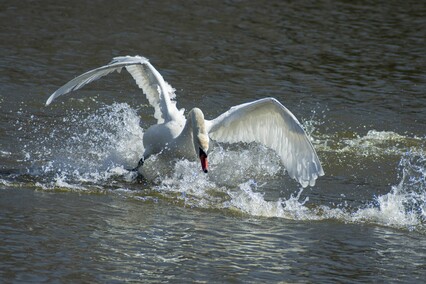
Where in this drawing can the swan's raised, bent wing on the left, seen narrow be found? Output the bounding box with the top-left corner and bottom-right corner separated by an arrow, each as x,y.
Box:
46,56 -> 183,123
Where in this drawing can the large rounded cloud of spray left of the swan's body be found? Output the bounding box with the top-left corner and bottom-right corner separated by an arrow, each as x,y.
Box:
23,103 -> 143,187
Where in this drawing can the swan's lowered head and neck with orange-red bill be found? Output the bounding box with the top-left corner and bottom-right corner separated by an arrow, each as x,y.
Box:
190,108 -> 209,173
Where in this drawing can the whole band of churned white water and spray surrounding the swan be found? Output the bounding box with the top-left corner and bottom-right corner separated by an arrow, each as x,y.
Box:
5,103 -> 426,233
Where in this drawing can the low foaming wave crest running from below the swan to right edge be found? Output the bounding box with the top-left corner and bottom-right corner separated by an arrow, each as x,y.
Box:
147,150 -> 426,233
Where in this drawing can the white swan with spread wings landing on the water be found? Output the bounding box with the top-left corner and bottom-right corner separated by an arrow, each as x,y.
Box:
46,56 -> 324,187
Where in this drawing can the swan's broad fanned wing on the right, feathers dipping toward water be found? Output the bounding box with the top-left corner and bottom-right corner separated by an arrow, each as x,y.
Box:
207,98 -> 324,187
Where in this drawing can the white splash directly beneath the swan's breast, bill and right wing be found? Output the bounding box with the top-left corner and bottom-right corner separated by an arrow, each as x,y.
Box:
143,144 -> 282,209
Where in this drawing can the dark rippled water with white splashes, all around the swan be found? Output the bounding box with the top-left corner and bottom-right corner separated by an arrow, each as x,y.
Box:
0,1 -> 426,283
